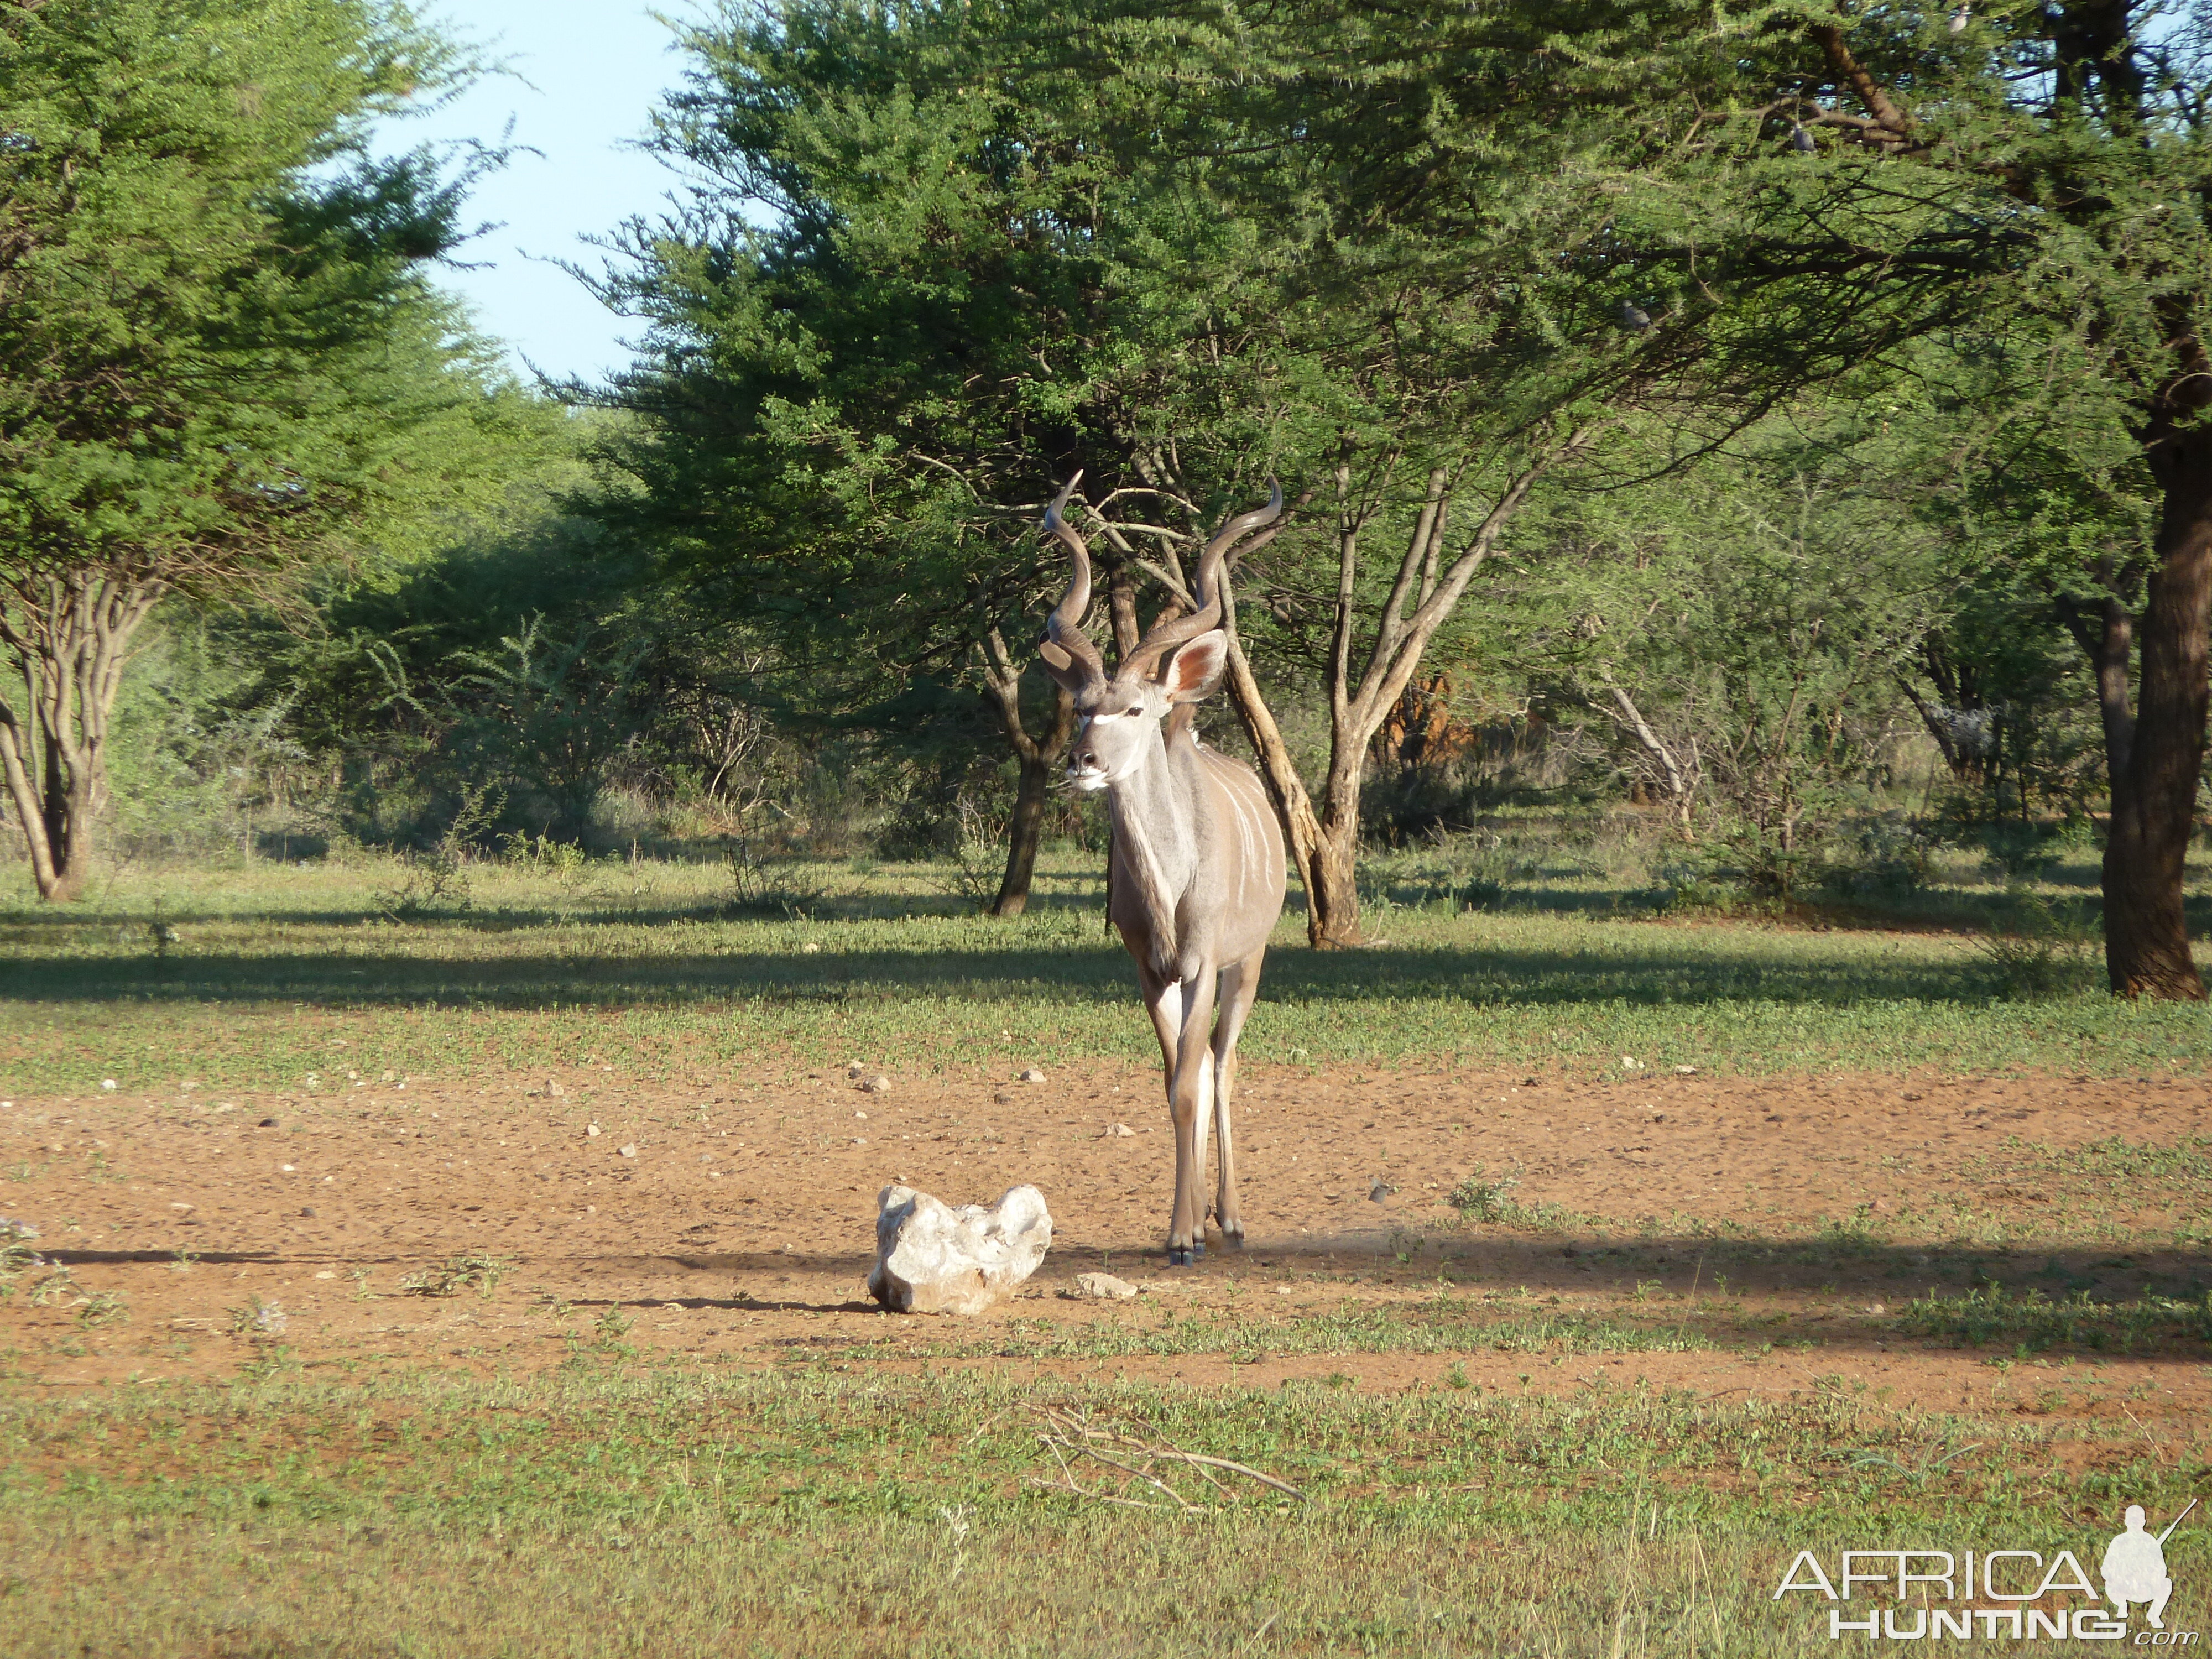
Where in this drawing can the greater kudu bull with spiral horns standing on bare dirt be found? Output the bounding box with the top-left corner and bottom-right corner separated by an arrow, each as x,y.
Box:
1037,473 -> 1287,1267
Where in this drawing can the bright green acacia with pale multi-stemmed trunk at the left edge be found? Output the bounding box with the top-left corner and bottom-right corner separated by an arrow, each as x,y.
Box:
0,0 -> 507,900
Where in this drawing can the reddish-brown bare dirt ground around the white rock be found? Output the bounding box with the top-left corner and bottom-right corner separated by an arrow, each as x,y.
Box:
0,1055 -> 2212,1431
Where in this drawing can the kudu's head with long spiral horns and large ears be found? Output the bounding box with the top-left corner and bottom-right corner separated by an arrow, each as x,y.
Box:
1037,473 -> 1283,794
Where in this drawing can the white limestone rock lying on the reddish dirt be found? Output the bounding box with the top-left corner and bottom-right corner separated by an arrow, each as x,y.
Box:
867,1183 -> 1053,1314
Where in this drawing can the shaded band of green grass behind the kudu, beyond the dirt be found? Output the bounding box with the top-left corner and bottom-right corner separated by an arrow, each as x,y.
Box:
0,854 -> 2212,1091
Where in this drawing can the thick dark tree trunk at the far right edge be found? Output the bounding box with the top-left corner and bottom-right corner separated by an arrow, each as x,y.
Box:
2099,420 -> 2212,1002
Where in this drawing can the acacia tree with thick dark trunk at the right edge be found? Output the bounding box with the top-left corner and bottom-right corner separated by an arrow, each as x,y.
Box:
1778,0 -> 2212,1000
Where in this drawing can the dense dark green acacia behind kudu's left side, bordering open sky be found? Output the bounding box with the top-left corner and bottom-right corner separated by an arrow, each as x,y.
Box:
597,0 -> 1345,916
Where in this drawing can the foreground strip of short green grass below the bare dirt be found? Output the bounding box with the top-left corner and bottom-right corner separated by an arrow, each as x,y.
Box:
0,1360 -> 2212,1659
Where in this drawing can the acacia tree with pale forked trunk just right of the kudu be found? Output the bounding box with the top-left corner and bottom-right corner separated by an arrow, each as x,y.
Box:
1024,23 -> 1681,949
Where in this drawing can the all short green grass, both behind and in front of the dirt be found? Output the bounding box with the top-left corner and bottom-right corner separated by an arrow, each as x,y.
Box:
0,856 -> 2212,1659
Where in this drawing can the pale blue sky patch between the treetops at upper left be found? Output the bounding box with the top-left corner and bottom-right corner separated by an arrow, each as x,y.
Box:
385,0 -> 699,376
